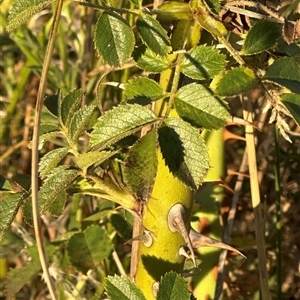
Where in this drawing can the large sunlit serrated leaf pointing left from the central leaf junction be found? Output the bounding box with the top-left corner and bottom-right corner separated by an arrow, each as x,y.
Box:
90,104 -> 157,149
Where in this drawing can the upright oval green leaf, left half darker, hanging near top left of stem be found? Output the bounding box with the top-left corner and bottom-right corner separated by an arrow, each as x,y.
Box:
94,12 -> 135,66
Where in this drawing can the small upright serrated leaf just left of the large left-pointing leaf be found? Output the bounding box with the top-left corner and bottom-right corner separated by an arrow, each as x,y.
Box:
69,105 -> 96,143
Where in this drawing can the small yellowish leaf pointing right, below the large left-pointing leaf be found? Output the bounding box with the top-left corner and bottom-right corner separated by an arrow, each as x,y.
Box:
77,151 -> 116,170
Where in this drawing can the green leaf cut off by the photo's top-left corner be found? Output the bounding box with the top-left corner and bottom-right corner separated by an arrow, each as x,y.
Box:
6,0 -> 55,32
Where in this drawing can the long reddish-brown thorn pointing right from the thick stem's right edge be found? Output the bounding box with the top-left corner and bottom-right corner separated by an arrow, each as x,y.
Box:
189,228 -> 246,258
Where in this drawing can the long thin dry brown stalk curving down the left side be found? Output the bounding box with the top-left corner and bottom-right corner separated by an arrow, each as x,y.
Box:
31,0 -> 63,300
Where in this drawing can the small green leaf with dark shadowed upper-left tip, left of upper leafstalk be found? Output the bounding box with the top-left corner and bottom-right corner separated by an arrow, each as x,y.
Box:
133,45 -> 170,73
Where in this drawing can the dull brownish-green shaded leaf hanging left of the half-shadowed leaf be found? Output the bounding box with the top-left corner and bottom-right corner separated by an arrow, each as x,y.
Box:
124,130 -> 157,201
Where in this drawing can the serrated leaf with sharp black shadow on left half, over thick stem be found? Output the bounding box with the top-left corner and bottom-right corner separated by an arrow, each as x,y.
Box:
159,118 -> 209,188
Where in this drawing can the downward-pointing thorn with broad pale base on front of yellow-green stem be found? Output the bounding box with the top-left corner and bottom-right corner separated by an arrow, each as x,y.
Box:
168,203 -> 196,267
